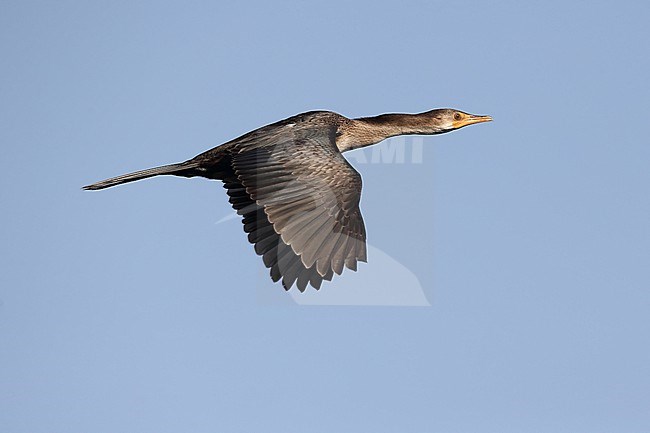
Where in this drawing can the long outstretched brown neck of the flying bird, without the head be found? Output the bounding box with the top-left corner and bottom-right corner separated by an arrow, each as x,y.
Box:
336,113 -> 442,152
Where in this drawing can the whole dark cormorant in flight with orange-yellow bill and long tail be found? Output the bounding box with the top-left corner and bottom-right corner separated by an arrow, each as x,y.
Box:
83,108 -> 492,292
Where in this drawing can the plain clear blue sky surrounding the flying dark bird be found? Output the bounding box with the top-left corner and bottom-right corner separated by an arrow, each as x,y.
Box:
0,1 -> 650,433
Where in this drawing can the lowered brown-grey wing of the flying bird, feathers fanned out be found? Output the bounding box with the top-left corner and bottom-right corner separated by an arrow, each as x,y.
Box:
224,121 -> 366,291
